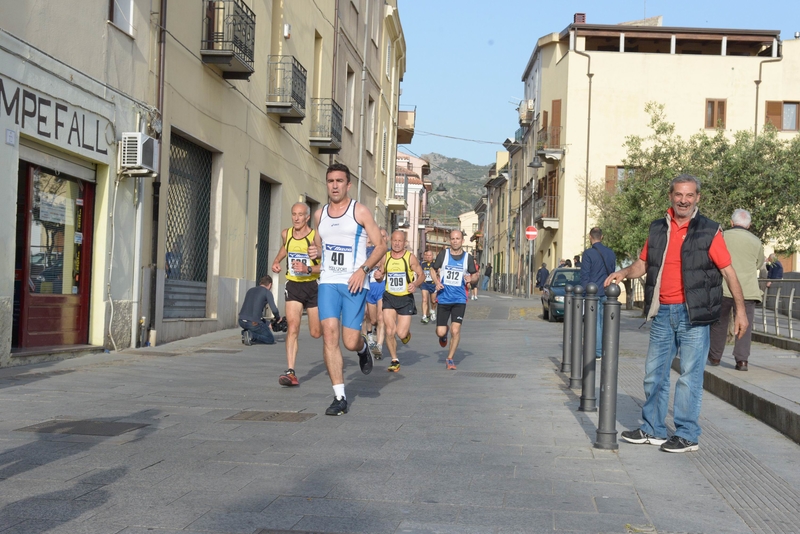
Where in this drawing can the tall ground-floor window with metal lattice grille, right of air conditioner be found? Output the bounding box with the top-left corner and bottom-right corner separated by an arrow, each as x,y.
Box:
164,133 -> 211,318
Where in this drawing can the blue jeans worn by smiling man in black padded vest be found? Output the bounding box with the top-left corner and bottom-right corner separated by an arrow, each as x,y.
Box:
642,304 -> 710,442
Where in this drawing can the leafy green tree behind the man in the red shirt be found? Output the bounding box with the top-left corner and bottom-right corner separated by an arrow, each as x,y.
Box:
589,102 -> 800,261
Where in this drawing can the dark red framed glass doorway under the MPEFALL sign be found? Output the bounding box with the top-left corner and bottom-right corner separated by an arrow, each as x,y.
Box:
11,161 -> 94,348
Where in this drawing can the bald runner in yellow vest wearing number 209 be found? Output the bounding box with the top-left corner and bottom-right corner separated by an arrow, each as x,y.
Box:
375,230 -> 425,373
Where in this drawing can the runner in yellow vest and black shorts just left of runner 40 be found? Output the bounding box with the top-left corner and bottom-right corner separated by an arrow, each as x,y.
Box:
272,202 -> 322,386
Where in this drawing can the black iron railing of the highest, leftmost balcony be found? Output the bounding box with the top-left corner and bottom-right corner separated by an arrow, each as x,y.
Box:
200,0 -> 256,71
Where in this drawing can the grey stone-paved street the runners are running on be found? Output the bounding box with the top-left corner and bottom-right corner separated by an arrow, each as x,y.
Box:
0,293 -> 800,534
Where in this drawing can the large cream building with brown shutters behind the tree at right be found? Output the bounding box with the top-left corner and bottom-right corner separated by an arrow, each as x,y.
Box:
520,14 -> 800,268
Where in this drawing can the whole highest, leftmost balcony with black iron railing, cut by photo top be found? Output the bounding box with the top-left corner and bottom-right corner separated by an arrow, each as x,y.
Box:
200,0 -> 256,80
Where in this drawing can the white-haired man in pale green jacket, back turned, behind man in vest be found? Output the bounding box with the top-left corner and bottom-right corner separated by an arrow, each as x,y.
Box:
708,209 -> 764,371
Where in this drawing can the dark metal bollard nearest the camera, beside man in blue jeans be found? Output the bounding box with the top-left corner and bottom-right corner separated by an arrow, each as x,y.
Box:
594,284 -> 621,450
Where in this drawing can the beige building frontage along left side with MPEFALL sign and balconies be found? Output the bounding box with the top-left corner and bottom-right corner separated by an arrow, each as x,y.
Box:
0,0 -> 413,366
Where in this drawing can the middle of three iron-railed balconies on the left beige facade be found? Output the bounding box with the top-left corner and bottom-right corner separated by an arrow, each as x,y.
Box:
267,56 -> 307,123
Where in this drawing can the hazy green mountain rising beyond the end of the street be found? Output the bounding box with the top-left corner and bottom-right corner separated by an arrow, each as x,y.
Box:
422,153 -> 491,226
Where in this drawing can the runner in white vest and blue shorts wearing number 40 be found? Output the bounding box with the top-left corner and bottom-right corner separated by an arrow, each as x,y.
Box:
308,163 -> 386,415
